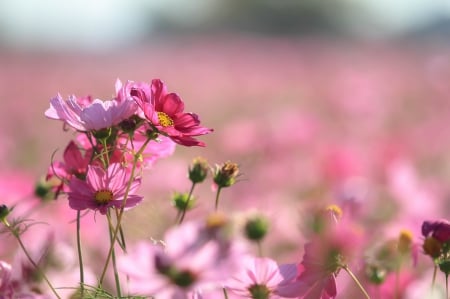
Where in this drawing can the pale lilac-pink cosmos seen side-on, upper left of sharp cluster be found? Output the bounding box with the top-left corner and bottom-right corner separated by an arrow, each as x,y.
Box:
45,94 -> 137,131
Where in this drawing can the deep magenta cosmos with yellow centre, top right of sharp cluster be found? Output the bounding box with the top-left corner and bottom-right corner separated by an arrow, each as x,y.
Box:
129,79 -> 213,146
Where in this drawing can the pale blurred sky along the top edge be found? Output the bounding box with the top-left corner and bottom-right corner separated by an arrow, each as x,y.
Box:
0,0 -> 450,50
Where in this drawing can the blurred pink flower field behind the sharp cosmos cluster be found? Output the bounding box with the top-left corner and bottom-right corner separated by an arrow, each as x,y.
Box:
0,36 -> 450,299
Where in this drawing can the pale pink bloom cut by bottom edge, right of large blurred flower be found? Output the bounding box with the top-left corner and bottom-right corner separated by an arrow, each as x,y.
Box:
225,256 -> 297,299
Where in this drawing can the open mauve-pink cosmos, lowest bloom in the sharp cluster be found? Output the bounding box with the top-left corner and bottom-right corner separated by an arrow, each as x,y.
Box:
68,163 -> 143,214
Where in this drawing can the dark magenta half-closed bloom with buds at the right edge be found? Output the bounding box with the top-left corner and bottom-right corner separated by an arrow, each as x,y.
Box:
422,219 -> 450,275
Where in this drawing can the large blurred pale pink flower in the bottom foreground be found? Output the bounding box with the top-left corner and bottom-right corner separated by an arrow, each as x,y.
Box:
119,222 -> 246,299
